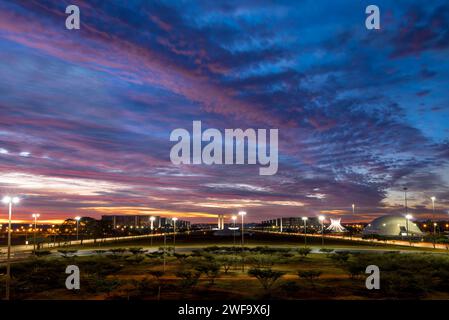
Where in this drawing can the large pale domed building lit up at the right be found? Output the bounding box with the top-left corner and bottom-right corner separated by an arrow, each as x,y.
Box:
363,216 -> 423,237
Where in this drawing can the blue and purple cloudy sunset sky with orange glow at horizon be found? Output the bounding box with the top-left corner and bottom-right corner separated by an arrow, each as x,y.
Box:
0,0 -> 449,222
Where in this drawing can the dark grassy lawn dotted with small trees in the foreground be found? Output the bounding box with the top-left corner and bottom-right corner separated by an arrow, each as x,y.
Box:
0,237 -> 449,300
